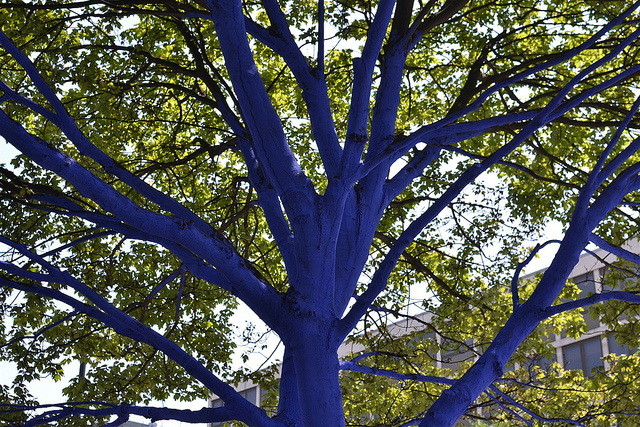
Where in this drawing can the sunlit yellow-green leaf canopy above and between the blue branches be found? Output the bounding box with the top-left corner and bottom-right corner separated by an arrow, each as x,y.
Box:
0,0 -> 640,421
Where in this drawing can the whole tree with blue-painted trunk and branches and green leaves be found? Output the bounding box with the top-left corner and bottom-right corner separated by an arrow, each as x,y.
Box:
0,0 -> 640,427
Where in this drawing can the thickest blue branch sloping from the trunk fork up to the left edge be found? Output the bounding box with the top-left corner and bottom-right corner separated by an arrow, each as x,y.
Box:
0,112 -> 281,332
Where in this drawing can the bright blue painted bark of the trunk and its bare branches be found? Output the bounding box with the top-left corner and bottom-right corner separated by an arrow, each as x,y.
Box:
0,1 -> 640,427
